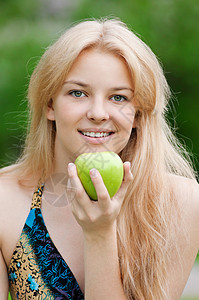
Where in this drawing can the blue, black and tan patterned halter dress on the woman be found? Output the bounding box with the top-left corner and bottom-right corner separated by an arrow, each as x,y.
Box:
8,185 -> 84,300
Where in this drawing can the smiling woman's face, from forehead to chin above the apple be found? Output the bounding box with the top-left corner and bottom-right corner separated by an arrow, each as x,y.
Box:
47,49 -> 135,169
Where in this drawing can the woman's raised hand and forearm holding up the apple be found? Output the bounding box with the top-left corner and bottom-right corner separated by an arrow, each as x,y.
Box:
68,162 -> 133,300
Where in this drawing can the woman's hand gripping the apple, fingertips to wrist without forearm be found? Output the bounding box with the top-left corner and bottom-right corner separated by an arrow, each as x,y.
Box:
67,162 -> 133,238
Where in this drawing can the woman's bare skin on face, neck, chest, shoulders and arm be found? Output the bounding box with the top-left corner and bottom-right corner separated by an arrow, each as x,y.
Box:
0,49 -> 199,300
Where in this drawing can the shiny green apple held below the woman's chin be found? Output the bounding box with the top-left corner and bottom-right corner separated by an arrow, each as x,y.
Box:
75,151 -> 124,200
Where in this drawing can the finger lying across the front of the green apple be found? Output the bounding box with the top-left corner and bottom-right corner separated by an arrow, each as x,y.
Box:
90,169 -> 110,208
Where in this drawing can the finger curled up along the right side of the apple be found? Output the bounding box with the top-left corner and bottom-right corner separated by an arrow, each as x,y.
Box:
114,161 -> 133,201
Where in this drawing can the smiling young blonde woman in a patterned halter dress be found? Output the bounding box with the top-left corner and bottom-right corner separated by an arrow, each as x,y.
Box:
0,20 -> 199,300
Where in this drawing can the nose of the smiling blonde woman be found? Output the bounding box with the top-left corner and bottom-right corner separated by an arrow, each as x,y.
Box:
87,98 -> 109,122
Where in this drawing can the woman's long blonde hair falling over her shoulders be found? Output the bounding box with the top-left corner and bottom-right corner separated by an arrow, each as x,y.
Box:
2,19 -> 194,300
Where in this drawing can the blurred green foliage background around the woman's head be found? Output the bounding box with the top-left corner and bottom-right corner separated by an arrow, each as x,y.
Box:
0,0 -> 199,299
